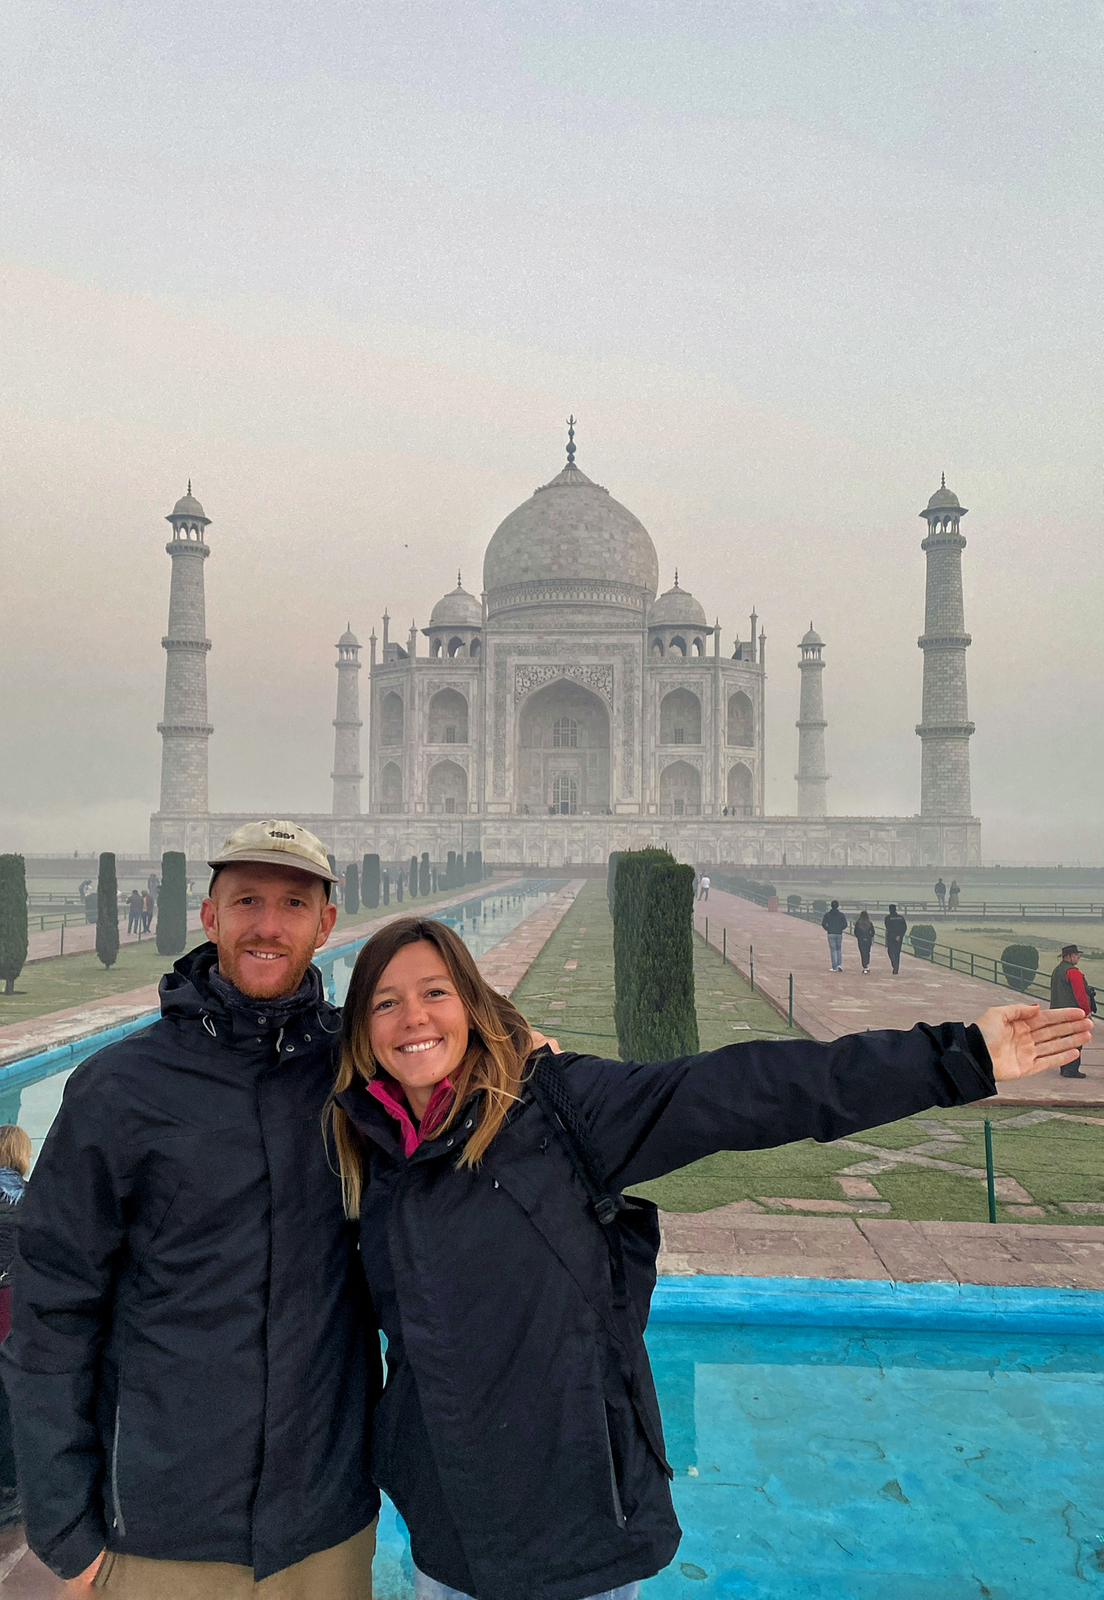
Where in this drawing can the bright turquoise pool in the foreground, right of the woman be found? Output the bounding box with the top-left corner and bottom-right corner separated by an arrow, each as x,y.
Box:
376,1280 -> 1104,1600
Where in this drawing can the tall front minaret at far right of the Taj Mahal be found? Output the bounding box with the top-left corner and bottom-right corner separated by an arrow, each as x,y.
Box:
917,474 -> 974,818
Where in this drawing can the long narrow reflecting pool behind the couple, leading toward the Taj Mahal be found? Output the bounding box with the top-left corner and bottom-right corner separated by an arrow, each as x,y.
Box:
0,878 -> 563,1152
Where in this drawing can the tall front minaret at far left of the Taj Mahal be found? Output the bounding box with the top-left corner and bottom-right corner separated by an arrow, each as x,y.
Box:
157,478 -> 213,816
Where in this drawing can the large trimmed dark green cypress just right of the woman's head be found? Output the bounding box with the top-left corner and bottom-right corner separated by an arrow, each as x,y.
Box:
627,861 -> 698,1061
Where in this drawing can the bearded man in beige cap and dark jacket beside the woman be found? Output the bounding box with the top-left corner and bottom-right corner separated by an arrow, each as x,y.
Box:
3,822 -> 379,1600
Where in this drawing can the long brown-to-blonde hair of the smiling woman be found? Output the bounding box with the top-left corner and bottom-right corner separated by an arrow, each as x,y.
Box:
328,917 -> 531,1216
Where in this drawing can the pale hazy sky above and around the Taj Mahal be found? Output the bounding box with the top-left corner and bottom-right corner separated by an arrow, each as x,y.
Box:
0,0 -> 1104,862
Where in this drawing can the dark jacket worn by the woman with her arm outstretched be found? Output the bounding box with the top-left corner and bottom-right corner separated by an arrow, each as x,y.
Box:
339,1024 -> 994,1600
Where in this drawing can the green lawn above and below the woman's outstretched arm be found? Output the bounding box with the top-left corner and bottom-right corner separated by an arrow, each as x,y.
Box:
515,882 -> 1104,1224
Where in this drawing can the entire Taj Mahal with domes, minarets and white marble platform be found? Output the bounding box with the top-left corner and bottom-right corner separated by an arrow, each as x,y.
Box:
150,418 -> 981,869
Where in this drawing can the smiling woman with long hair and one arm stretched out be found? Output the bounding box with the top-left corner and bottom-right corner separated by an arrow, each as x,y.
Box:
333,917 -> 1090,1600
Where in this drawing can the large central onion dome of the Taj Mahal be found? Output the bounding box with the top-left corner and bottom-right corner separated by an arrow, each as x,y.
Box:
483,462 -> 659,613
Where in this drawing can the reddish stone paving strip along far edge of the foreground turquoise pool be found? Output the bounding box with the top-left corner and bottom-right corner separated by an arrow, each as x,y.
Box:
659,1205 -> 1104,1290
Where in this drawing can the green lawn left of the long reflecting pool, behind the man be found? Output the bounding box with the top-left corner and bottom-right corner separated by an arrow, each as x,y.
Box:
0,890 -> 466,1027
